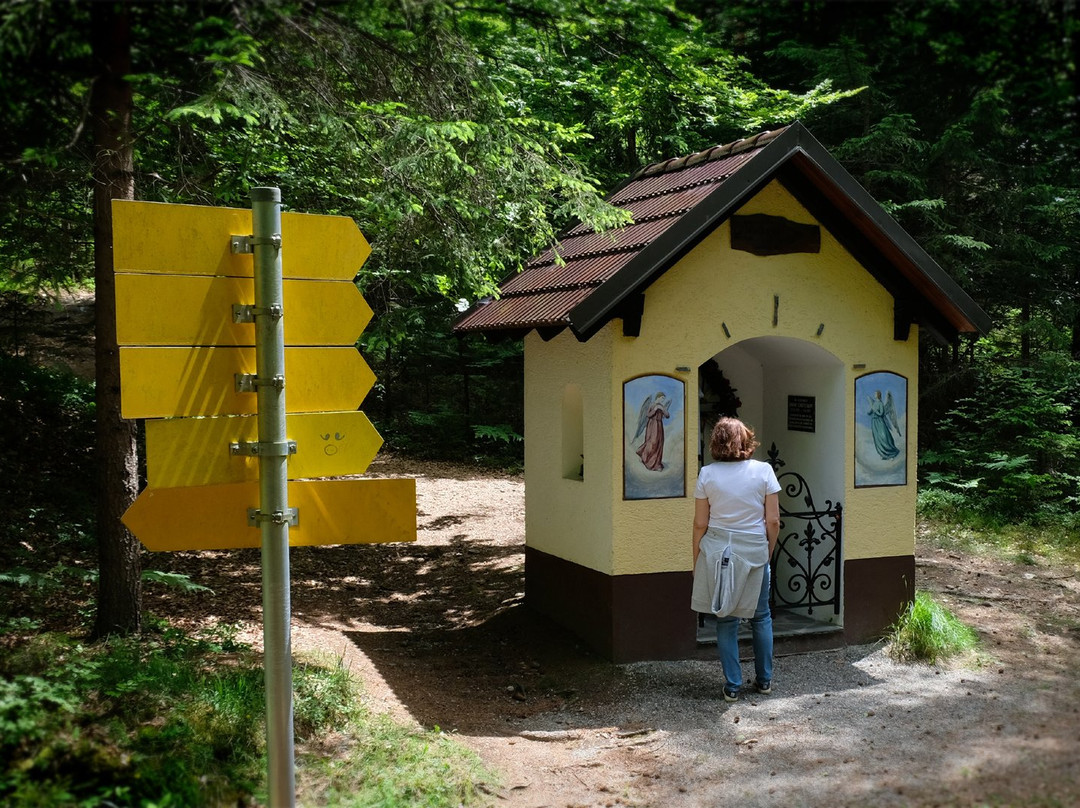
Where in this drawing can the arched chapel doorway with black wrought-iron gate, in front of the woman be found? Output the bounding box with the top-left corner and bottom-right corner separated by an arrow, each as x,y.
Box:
698,336 -> 848,638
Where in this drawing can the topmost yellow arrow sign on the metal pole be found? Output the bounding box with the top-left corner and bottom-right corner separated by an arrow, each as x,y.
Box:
112,200 -> 372,281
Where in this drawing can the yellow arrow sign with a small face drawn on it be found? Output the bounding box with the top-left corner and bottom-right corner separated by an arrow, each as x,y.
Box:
146,410 -> 382,488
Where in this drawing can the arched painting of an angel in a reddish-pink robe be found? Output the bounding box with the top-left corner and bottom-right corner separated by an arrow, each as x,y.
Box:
622,374 -> 686,499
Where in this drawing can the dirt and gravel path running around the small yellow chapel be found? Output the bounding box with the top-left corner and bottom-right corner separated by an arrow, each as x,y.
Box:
148,459 -> 1080,808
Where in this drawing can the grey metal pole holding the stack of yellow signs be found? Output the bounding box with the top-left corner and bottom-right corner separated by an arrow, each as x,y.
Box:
252,188 -> 296,808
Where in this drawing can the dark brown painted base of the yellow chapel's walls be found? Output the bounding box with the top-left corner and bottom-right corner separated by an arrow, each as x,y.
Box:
525,547 -> 915,662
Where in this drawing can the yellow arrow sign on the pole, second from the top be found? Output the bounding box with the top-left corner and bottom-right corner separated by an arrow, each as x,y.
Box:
116,273 -> 372,346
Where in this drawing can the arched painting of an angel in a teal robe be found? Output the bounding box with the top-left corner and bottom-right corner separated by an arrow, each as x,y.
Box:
855,371 -> 907,487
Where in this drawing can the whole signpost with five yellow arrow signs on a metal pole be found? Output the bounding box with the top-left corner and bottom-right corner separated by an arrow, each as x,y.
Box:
113,188 -> 416,808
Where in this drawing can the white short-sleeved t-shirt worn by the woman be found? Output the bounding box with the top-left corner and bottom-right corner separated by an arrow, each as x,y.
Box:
693,460 -> 780,535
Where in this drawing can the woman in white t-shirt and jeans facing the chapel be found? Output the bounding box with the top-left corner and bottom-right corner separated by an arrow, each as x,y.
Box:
690,418 -> 780,701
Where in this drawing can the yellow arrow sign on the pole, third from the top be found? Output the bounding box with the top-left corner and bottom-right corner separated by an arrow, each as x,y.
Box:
120,348 -> 375,418
